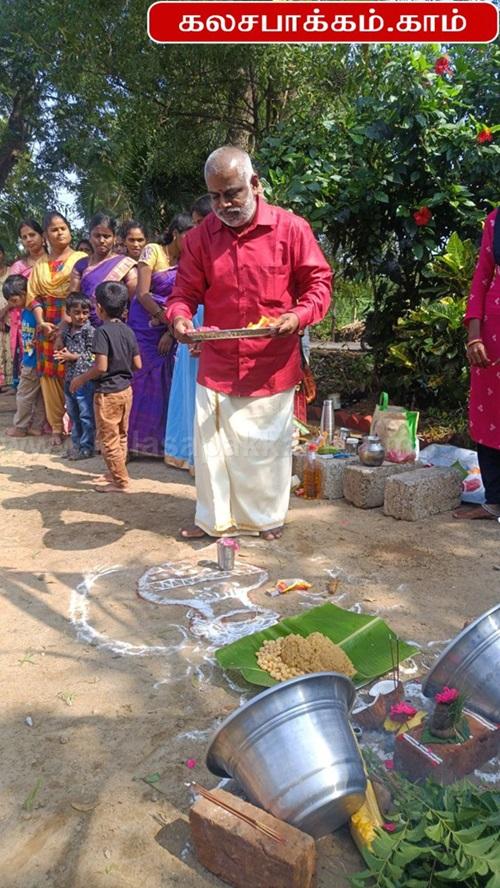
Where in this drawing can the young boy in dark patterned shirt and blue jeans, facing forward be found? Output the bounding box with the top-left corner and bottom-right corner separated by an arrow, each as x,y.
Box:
54,293 -> 95,460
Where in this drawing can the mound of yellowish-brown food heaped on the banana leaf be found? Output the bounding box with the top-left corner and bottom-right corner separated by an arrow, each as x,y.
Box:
256,632 -> 356,681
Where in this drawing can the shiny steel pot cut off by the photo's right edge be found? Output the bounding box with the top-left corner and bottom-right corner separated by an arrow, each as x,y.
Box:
423,604 -> 500,722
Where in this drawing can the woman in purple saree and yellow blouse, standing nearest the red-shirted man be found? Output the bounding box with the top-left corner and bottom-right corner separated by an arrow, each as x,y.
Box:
128,213 -> 193,456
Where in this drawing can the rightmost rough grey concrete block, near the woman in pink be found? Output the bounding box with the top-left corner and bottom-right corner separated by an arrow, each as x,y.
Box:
384,466 -> 462,521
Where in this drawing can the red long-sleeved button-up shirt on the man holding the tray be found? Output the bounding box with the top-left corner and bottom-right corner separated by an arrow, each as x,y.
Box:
166,198 -> 332,397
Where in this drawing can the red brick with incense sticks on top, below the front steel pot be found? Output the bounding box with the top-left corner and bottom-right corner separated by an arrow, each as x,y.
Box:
189,789 -> 316,888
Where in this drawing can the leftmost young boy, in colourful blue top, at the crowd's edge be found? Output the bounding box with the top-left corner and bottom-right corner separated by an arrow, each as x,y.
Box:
2,274 -> 45,438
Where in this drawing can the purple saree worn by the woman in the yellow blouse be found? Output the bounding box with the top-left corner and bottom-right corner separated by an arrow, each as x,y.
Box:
128,268 -> 177,457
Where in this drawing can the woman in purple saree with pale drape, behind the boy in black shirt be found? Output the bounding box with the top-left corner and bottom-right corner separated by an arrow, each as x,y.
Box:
70,213 -> 137,327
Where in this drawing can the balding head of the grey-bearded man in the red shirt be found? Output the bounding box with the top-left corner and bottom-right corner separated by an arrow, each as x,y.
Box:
205,145 -> 259,228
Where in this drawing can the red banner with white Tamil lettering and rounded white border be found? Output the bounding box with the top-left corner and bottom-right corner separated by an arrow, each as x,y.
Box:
148,0 -> 498,43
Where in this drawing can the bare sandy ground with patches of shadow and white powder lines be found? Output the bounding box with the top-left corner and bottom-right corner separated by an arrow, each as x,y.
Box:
0,395 -> 500,888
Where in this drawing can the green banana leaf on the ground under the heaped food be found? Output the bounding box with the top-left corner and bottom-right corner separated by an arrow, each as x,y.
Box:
215,604 -> 419,688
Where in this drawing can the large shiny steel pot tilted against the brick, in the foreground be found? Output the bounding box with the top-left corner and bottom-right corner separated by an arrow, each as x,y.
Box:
207,672 -> 366,837
